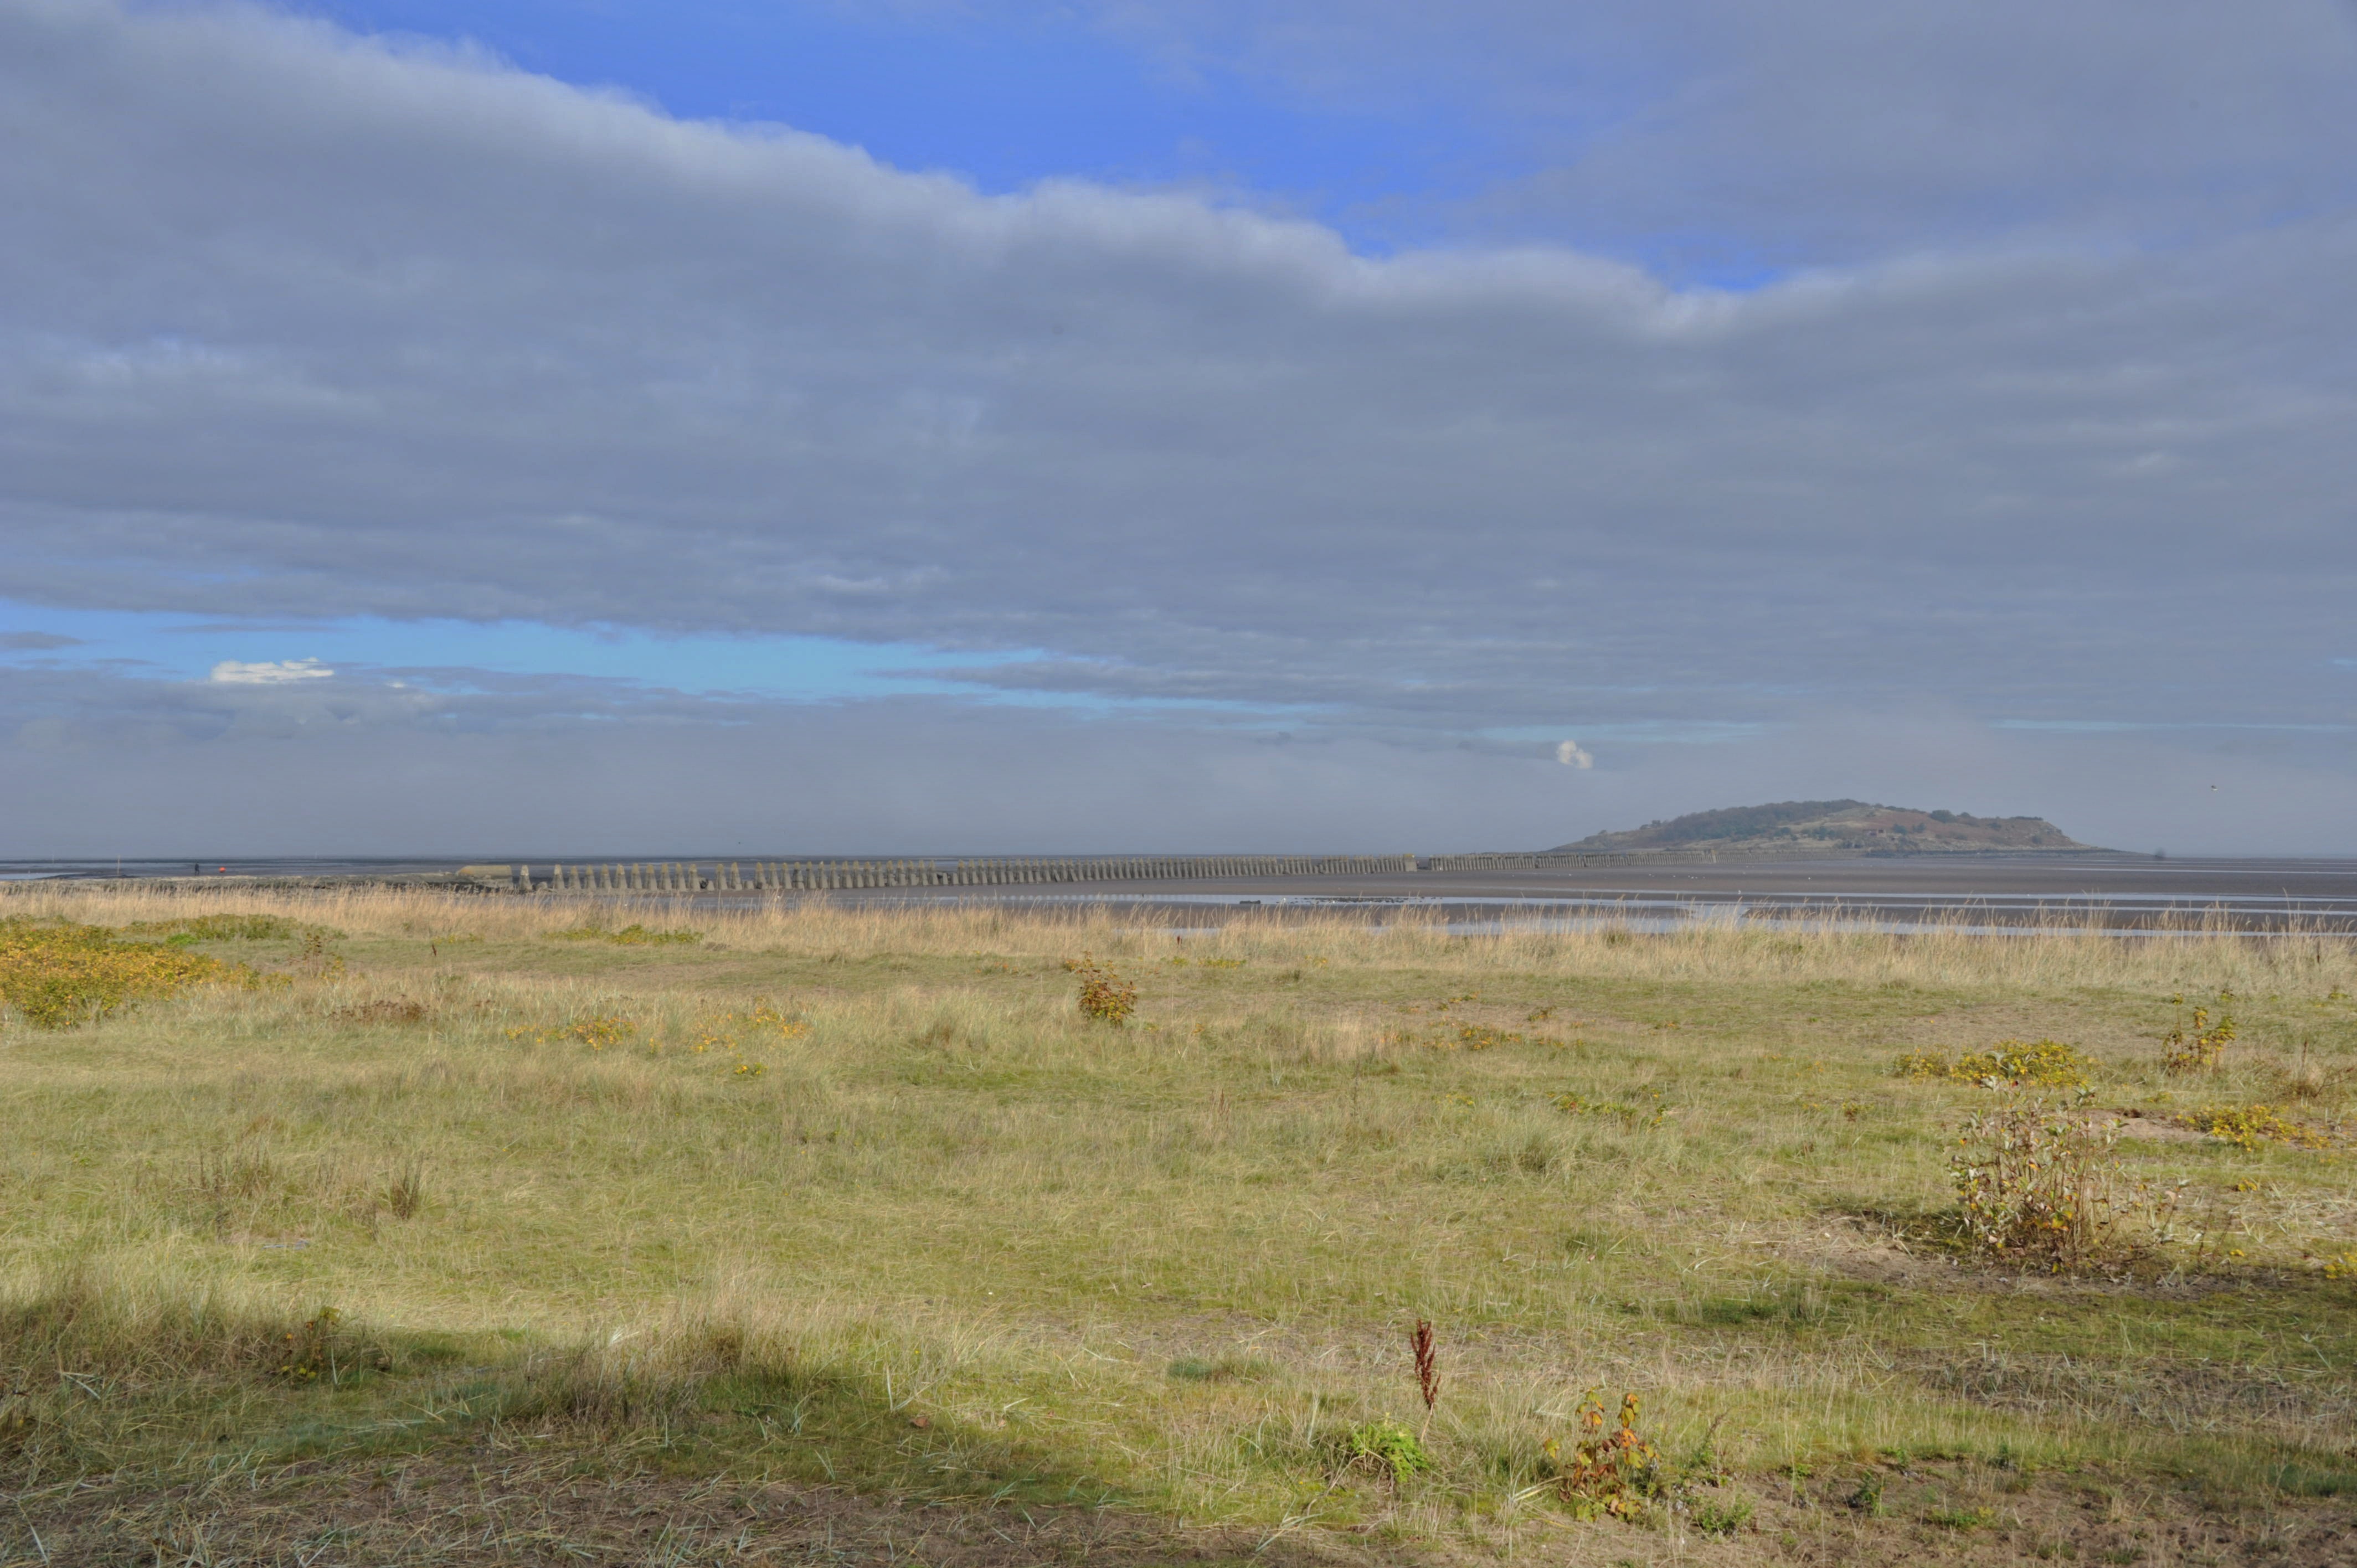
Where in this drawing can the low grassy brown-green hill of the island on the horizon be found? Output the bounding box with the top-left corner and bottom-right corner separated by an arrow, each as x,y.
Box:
1556,800 -> 2086,854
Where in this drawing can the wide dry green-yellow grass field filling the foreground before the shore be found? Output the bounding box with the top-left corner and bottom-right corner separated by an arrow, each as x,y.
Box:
0,889 -> 2357,1566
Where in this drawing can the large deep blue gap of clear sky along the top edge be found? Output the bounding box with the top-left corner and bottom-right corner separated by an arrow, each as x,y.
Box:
306,2 -> 1513,247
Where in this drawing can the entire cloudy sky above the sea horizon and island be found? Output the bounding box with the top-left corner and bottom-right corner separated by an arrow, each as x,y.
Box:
0,0 -> 2357,858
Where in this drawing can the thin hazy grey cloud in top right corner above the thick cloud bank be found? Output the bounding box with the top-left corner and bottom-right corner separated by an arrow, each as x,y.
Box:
1079,0 -> 2357,266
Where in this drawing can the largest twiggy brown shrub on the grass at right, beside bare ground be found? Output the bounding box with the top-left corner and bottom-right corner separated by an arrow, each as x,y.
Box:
1949,1099 -> 2121,1273
